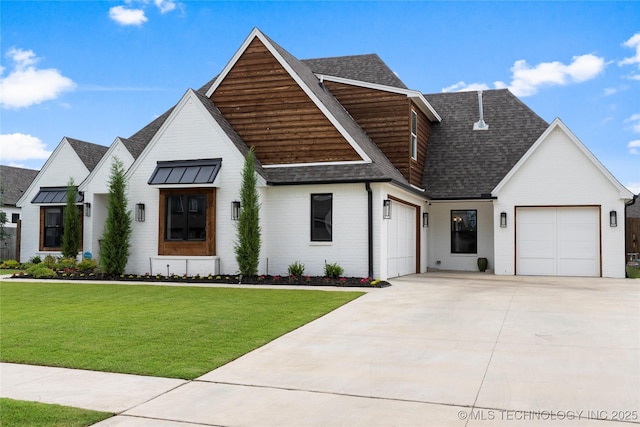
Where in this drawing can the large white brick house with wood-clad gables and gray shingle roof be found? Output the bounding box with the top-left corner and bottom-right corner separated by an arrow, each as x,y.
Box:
16,29 -> 632,279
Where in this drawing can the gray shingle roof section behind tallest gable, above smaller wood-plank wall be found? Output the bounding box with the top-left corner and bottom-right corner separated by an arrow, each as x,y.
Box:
302,53 -> 407,89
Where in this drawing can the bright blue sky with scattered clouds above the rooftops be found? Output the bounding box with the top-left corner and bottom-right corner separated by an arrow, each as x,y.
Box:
0,0 -> 640,193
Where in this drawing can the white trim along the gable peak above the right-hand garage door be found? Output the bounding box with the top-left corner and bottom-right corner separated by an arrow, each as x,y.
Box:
491,117 -> 633,199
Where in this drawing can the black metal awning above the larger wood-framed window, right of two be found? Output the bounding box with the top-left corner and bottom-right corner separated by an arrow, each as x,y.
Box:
148,159 -> 222,185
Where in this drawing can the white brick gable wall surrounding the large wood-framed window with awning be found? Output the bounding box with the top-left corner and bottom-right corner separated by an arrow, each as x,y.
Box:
127,93 -> 251,274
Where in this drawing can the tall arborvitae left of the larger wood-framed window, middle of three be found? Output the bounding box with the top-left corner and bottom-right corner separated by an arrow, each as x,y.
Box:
100,158 -> 131,274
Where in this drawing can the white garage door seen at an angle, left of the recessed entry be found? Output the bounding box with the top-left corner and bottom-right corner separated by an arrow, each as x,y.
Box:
387,200 -> 416,277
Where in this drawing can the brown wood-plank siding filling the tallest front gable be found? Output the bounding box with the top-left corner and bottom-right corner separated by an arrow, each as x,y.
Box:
211,38 -> 362,165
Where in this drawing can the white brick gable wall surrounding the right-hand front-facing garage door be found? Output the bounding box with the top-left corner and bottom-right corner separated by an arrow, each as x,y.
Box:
493,127 -> 625,277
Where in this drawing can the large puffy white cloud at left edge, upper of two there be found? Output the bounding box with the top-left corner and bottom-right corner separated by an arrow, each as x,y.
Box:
0,48 -> 76,108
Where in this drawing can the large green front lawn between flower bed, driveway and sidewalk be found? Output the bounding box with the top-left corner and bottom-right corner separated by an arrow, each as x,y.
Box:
0,281 -> 362,379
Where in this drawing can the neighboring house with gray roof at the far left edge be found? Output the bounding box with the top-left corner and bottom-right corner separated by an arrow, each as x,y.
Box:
0,165 -> 38,260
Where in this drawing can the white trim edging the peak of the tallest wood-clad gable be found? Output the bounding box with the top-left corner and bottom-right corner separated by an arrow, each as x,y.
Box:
206,28 -> 372,167
